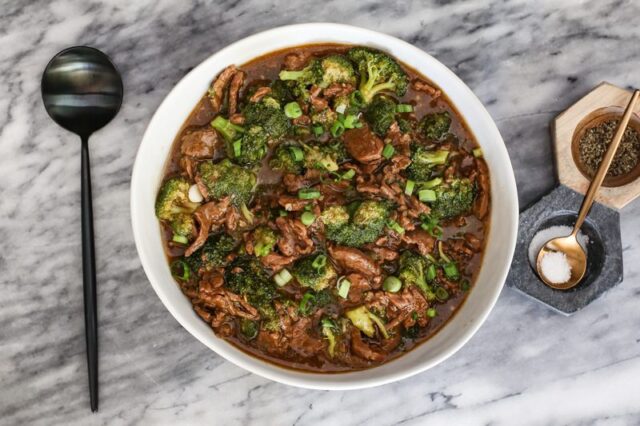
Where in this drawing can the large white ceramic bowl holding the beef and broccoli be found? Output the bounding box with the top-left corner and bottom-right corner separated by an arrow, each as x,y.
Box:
131,23 -> 518,389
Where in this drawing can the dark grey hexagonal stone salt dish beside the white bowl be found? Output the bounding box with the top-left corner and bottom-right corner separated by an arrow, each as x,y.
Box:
507,185 -> 622,315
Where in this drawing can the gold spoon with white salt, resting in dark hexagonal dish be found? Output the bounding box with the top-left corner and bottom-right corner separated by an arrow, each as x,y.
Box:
536,90 -> 640,290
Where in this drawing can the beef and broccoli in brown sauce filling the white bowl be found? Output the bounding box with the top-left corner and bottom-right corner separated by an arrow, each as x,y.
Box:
156,45 -> 490,372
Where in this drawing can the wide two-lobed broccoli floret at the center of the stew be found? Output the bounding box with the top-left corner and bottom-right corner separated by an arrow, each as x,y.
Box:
320,200 -> 389,247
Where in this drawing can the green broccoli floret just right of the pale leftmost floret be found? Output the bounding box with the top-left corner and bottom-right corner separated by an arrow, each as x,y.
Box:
198,158 -> 256,207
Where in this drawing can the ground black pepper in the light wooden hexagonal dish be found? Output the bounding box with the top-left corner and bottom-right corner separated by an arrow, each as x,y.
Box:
579,119 -> 640,177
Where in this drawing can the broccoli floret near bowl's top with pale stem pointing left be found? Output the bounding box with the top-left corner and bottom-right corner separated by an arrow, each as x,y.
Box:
279,55 -> 356,87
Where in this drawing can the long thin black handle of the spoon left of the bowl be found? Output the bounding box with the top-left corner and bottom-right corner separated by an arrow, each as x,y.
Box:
81,136 -> 98,412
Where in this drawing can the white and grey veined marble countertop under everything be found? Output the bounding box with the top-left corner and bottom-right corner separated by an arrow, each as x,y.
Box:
0,0 -> 640,425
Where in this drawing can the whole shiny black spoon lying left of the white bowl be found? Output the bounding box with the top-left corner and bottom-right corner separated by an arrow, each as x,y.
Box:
41,46 -> 123,411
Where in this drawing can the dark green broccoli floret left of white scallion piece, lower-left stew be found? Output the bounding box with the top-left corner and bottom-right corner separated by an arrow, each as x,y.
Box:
224,256 -> 277,310
